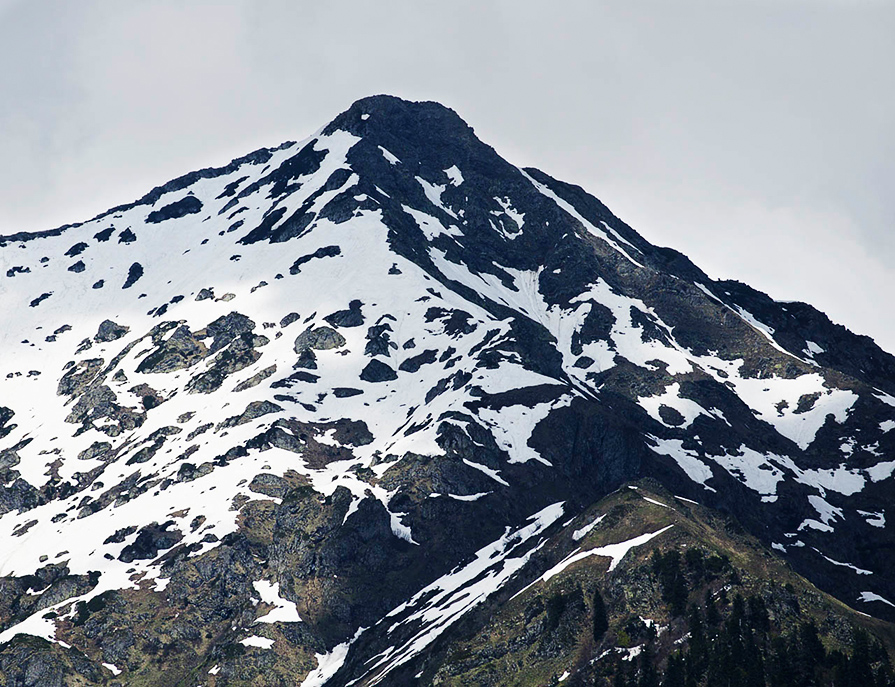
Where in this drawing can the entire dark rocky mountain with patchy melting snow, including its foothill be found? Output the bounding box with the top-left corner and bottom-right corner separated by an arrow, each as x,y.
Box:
0,96 -> 895,687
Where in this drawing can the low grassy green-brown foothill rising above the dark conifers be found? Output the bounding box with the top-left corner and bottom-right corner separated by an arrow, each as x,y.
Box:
420,481 -> 895,687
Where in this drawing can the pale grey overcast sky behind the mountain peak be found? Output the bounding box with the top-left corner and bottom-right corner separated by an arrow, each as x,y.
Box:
0,0 -> 895,352
